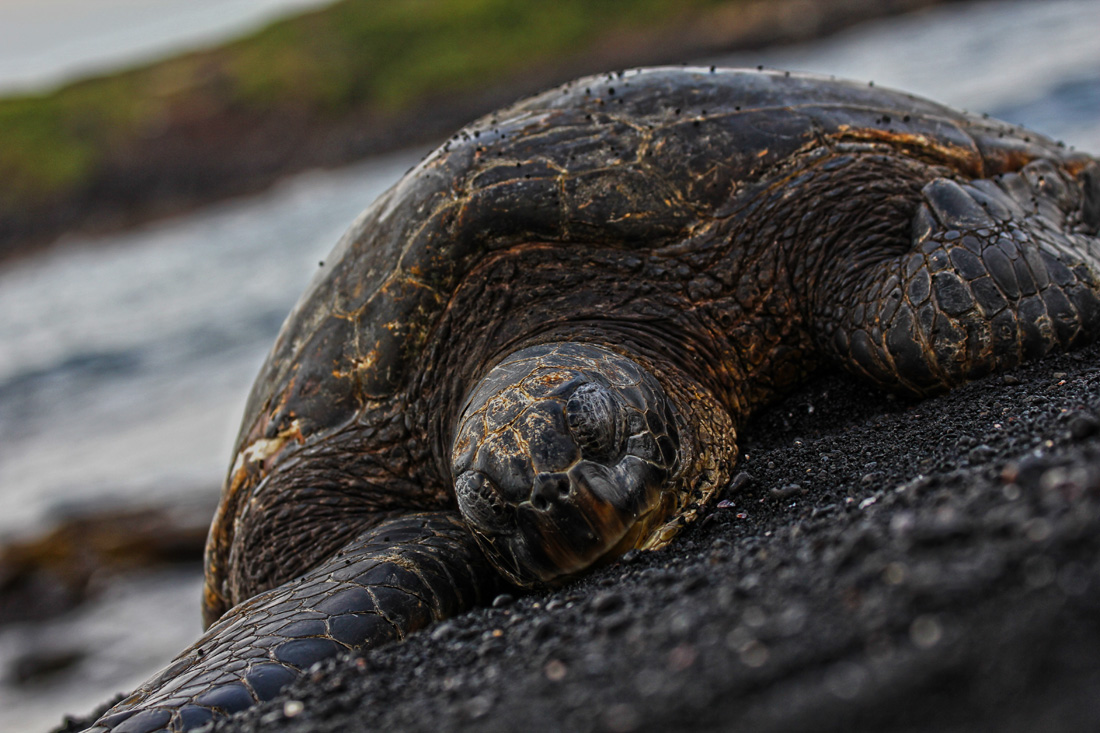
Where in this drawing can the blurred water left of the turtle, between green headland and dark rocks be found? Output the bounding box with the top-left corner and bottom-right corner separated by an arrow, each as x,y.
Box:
0,153 -> 418,535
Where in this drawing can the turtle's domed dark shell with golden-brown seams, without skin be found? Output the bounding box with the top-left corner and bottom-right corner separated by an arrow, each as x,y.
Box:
238,67 -> 1082,449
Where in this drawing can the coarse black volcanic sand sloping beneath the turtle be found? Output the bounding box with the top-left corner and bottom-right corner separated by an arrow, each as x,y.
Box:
64,347 -> 1100,733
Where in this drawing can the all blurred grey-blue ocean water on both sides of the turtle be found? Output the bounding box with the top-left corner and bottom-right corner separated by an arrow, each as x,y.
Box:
0,0 -> 1100,730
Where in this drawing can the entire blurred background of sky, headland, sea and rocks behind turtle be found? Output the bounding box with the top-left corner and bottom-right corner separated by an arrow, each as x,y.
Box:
0,0 -> 1100,731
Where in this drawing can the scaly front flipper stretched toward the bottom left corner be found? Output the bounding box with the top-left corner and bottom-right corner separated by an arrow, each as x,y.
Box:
81,512 -> 501,733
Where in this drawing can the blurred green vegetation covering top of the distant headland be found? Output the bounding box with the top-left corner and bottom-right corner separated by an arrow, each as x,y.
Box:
0,0 -> 736,206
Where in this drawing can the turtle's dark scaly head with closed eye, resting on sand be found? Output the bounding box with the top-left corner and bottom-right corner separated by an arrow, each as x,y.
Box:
451,342 -> 679,586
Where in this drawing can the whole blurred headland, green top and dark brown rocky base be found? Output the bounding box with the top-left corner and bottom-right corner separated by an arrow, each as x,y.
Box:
0,0 -> 952,262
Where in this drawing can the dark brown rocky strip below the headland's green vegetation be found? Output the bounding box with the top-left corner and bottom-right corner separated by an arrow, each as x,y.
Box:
0,0 -> 960,266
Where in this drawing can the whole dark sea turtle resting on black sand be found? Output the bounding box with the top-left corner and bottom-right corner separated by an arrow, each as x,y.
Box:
83,67 -> 1100,733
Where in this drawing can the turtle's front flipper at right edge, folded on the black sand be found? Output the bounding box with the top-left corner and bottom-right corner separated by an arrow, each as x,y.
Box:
813,158 -> 1100,395
